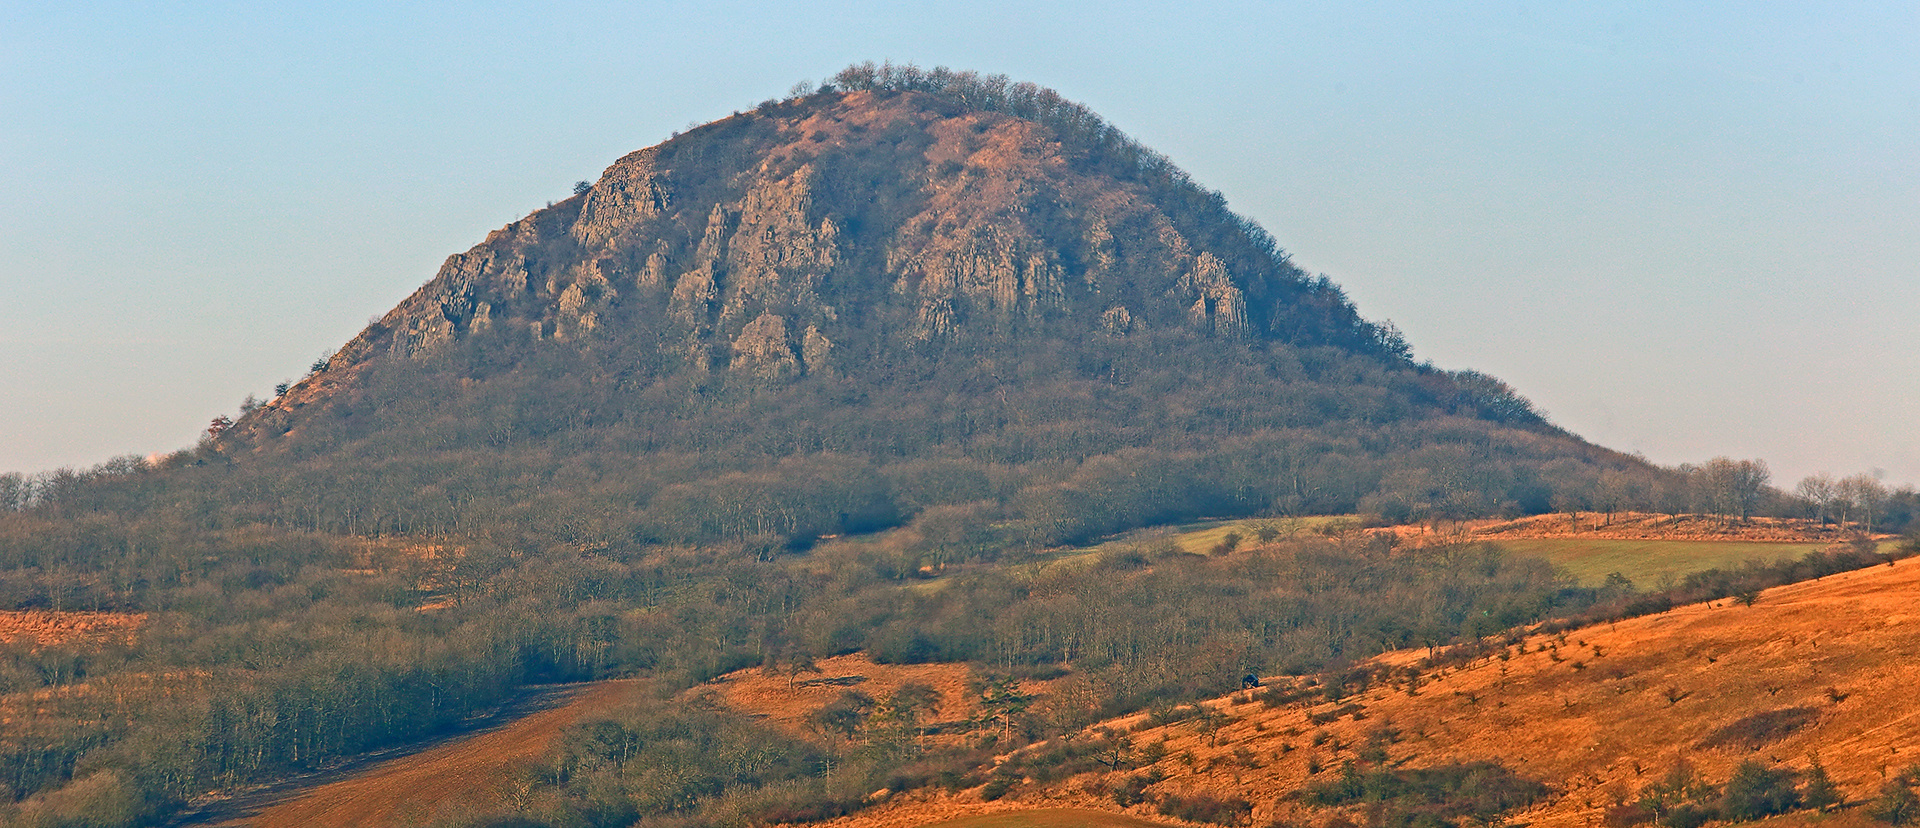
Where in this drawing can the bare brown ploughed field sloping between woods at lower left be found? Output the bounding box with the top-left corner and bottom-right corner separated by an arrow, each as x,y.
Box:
188,680 -> 639,828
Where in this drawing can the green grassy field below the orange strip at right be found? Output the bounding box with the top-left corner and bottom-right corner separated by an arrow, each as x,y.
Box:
1492,538 -> 1828,590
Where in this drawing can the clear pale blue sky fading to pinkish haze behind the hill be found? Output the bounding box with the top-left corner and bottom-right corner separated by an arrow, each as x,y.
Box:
11,0 -> 1920,488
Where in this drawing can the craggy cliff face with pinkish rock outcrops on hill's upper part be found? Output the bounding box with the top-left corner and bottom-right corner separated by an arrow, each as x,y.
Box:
284,92 -> 1377,414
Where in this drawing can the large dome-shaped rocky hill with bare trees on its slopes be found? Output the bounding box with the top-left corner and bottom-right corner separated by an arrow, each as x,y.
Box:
202,65 -> 1653,551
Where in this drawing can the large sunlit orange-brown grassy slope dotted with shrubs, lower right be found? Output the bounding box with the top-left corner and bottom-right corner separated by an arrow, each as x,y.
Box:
839,561 -> 1920,828
